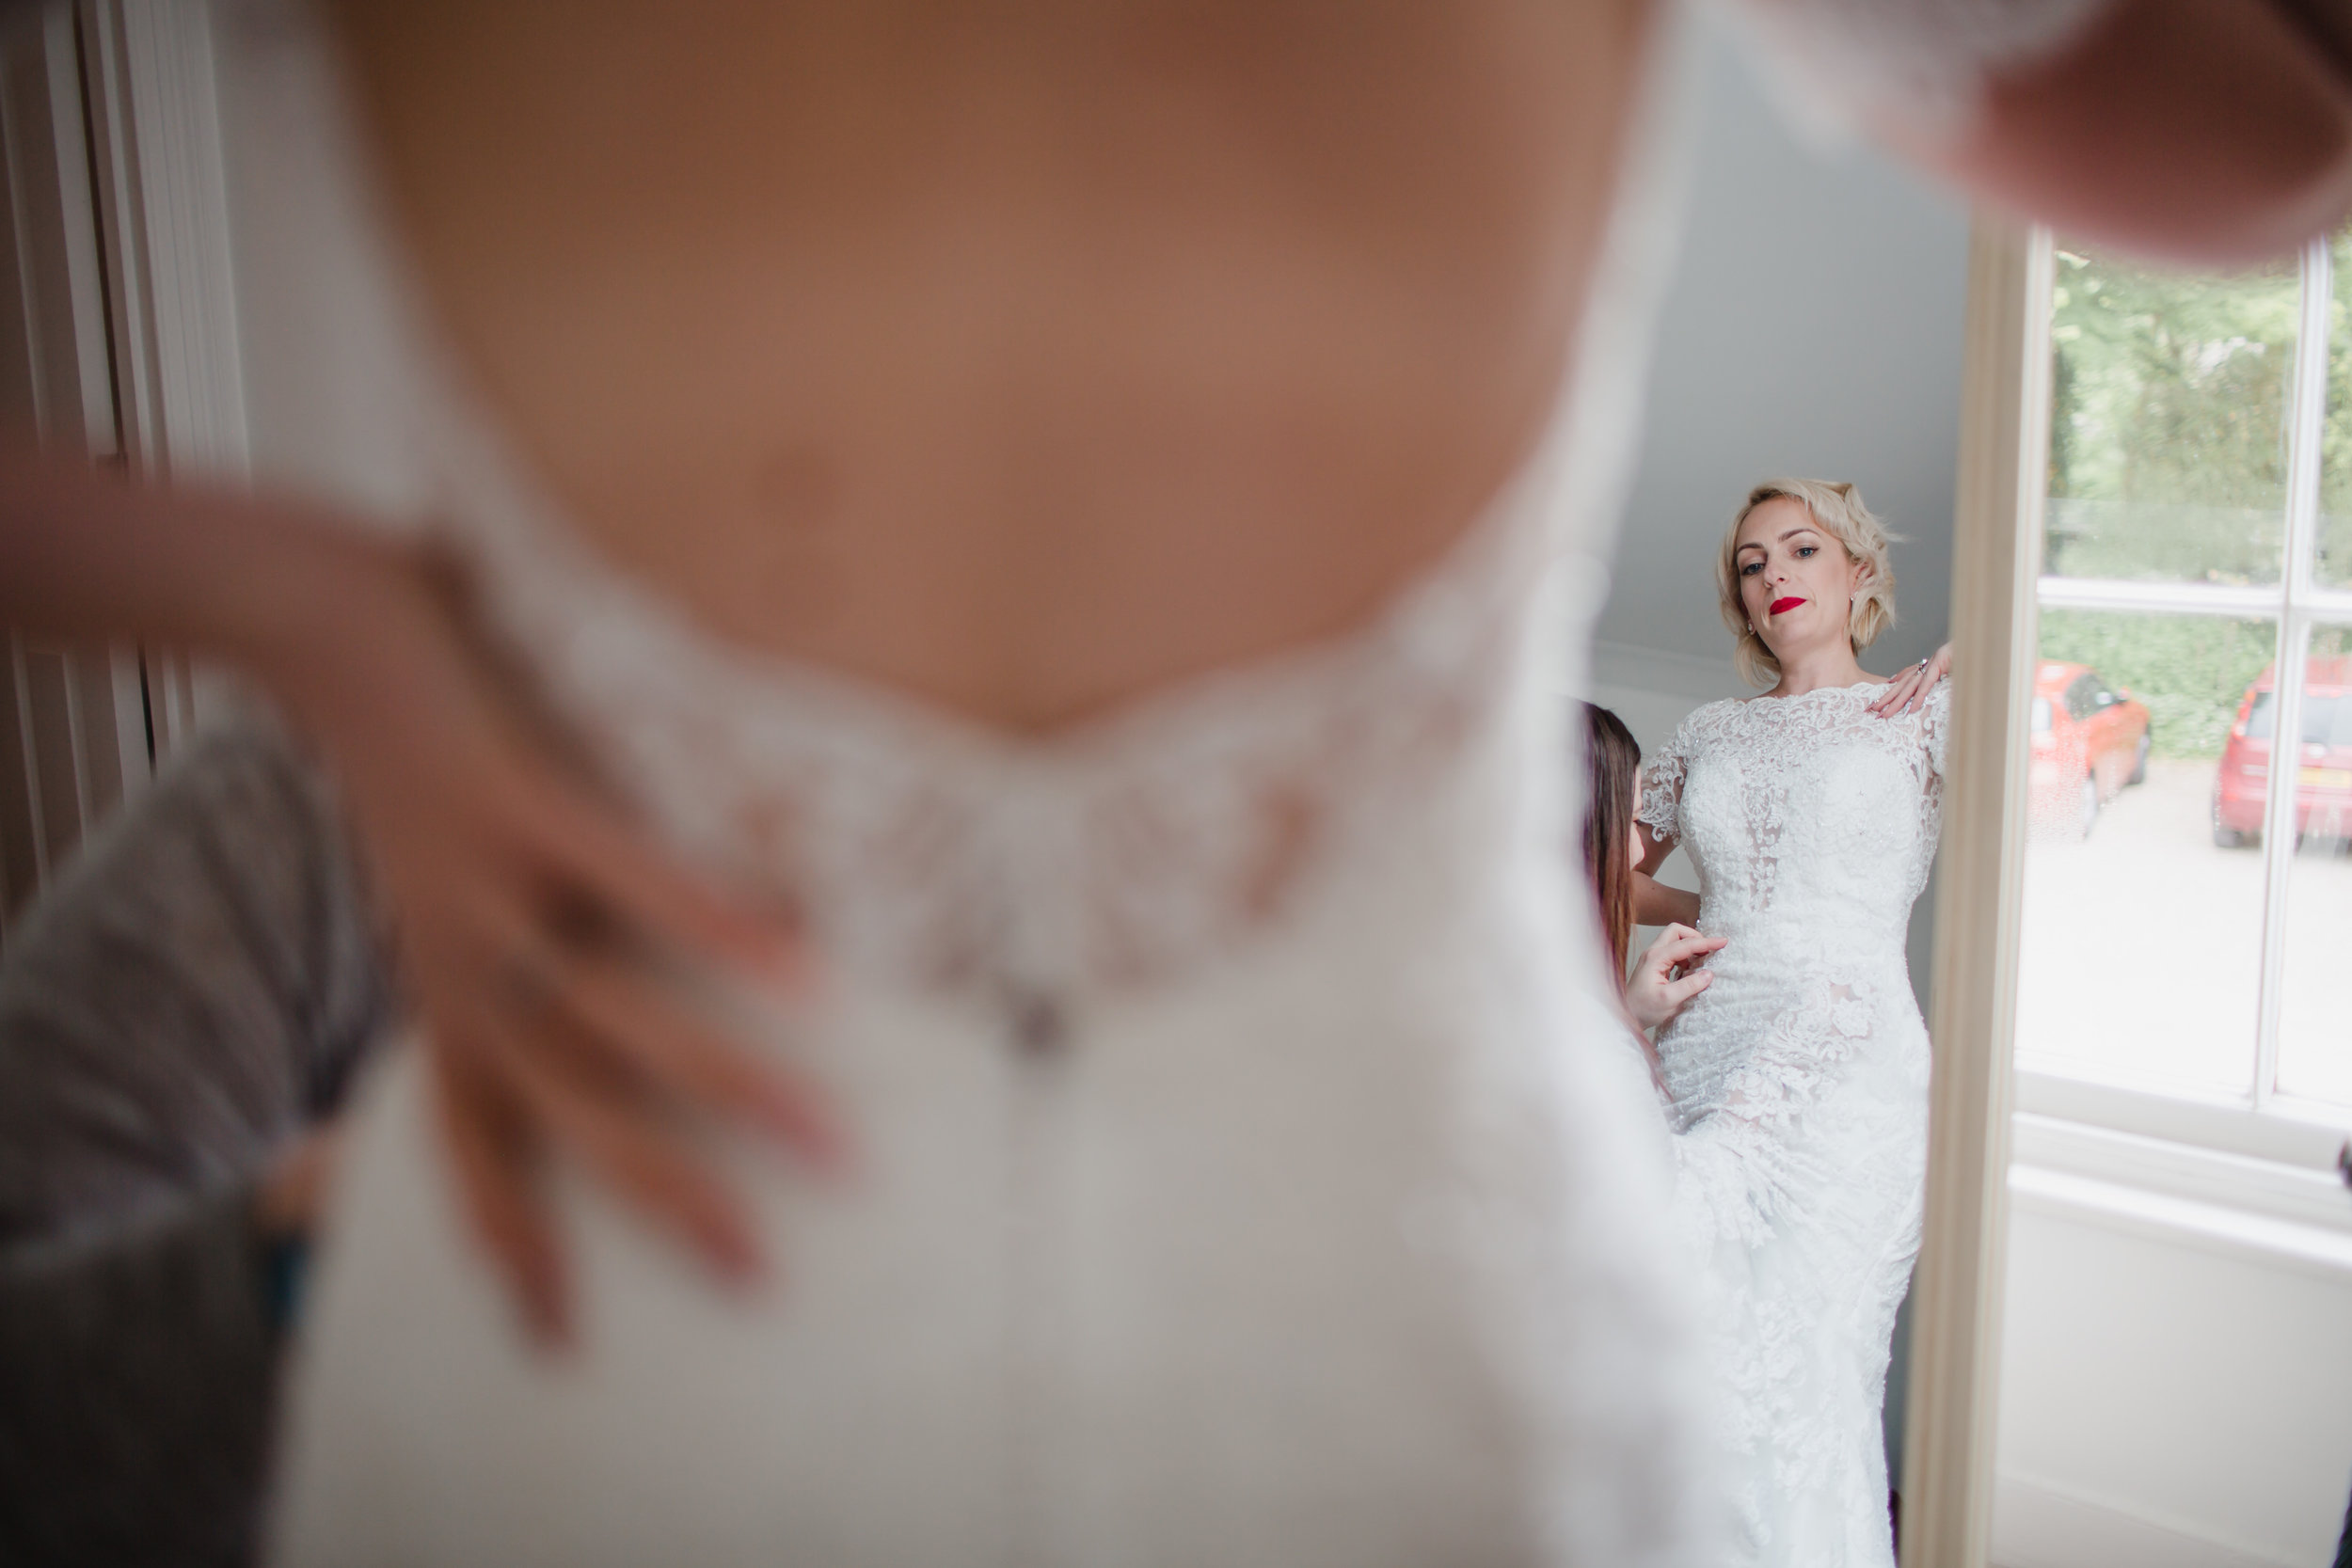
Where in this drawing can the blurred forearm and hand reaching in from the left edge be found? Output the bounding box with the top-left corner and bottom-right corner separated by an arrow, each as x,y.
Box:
0,442 -> 840,1336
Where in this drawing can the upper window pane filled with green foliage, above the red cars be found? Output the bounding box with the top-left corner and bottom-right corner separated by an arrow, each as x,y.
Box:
2042,246 -> 2286,583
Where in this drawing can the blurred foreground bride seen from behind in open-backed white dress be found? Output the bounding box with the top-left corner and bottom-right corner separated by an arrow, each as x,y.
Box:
0,0 -> 2352,1566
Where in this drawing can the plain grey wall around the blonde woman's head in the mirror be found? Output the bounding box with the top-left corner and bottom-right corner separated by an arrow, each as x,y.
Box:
1599,23 -> 1969,673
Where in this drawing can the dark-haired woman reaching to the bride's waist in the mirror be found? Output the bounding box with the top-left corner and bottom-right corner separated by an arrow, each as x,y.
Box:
1579,703 -> 1724,1034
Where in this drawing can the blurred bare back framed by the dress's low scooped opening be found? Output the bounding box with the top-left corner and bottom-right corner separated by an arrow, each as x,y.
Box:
342,0 -> 1649,731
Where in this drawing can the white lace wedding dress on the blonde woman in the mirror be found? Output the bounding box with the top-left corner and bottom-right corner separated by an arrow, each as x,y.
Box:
1642,684 -> 1950,1568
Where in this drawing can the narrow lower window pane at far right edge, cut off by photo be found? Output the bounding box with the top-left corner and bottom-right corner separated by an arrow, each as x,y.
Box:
2277,627 -> 2352,1105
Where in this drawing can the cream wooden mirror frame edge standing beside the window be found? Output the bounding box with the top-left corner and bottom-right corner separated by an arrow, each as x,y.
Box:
1900,212 -> 2051,1568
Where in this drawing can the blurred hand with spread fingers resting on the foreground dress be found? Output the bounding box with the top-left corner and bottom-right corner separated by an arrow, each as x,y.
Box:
262,545 -> 845,1340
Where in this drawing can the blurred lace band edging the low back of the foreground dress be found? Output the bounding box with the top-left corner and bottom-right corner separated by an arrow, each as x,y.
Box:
421,394 -> 1552,1011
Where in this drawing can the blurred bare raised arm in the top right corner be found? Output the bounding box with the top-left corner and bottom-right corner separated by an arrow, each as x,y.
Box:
1880,0 -> 2352,265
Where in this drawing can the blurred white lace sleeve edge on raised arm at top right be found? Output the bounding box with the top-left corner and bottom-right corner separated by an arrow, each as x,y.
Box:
1720,0 -> 2112,141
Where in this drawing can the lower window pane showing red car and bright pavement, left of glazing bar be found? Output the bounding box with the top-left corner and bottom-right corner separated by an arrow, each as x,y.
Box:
2018,609 -> 2277,1093
